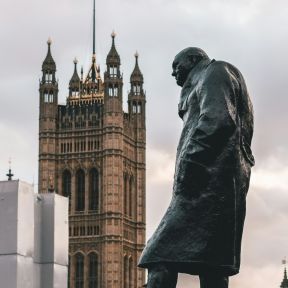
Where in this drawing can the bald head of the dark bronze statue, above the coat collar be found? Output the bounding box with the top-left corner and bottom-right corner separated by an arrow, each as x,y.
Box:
172,47 -> 209,87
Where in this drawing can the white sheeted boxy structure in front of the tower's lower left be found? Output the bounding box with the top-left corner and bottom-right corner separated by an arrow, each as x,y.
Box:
0,180 -> 68,288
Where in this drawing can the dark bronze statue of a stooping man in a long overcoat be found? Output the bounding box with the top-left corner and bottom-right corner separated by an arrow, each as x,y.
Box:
138,48 -> 254,288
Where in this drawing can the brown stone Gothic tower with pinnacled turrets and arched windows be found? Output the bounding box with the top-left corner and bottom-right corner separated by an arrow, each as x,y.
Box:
39,29 -> 146,288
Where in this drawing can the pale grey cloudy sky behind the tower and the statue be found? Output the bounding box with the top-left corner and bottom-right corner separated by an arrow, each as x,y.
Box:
0,0 -> 288,288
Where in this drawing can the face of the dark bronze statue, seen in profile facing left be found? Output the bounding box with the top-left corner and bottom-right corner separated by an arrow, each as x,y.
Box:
172,54 -> 194,87
